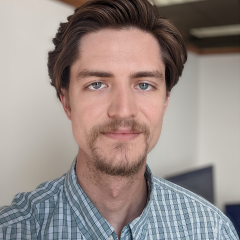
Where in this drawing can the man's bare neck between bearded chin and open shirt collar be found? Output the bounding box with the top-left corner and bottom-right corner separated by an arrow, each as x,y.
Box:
76,150 -> 147,238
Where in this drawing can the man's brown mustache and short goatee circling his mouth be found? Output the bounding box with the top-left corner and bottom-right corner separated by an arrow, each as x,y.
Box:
88,119 -> 150,177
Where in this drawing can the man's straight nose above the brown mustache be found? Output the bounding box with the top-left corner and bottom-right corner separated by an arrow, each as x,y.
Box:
108,84 -> 138,119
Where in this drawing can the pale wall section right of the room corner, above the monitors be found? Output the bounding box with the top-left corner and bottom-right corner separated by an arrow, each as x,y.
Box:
197,54 -> 240,209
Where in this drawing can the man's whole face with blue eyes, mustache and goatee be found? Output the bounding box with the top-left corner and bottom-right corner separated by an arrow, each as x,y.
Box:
61,28 -> 169,176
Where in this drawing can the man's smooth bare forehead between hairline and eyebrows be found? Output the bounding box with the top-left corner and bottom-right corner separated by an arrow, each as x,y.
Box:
72,28 -> 165,72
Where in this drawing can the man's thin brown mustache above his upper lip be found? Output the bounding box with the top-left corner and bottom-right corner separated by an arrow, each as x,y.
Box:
89,119 -> 150,143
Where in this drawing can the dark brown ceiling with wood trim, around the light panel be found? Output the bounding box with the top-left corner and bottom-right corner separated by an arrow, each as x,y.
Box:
58,0 -> 240,54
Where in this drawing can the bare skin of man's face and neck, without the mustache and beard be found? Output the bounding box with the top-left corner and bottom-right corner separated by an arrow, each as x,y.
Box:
61,28 -> 169,238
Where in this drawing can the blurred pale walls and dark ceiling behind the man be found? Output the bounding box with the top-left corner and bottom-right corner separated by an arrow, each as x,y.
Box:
0,0 -> 240,228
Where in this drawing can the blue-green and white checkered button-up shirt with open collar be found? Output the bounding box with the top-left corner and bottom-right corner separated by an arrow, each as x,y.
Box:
0,160 -> 238,240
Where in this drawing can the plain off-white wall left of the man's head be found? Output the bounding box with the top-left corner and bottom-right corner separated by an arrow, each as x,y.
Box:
0,0 -> 77,206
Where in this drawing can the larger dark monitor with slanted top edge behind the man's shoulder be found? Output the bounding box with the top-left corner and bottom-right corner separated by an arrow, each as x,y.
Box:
165,166 -> 214,204
